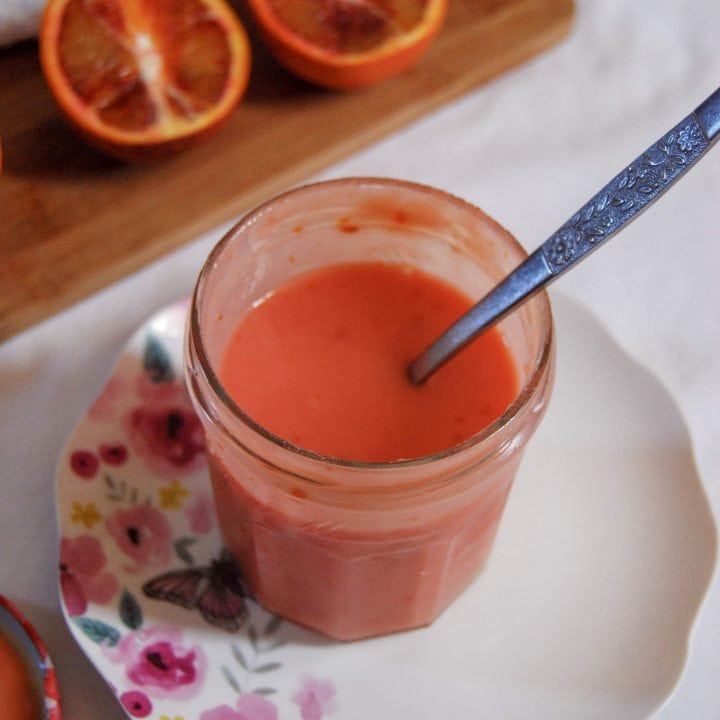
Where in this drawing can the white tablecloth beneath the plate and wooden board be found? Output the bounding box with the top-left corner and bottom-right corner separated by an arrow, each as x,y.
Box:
0,0 -> 720,720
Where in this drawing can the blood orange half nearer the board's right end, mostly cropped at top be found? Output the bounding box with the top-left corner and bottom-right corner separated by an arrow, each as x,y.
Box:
249,0 -> 448,89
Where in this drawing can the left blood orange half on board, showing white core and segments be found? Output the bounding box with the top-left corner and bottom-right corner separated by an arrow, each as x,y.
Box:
40,0 -> 250,159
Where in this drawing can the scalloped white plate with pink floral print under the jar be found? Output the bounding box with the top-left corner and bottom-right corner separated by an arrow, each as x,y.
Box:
57,297 -> 715,720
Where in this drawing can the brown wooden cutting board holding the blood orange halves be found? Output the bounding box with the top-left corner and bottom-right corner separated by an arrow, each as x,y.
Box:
0,0 -> 574,340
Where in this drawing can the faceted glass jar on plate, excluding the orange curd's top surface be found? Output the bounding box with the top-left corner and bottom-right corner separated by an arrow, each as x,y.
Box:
186,178 -> 554,640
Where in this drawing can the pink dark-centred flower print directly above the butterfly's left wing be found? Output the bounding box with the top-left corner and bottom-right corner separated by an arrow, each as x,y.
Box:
106,505 -> 172,572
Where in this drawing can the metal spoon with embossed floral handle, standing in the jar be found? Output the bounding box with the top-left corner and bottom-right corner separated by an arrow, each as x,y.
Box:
408,88 -> 720,384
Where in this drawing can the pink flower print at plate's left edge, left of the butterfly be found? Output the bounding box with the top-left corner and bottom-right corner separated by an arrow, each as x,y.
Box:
60,535 -> 120,616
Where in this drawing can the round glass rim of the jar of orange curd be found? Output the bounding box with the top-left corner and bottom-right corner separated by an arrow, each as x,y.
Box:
187,176 -> 554,471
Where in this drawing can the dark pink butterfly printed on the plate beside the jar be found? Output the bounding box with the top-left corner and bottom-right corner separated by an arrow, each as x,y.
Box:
142,549 -> 250,632
